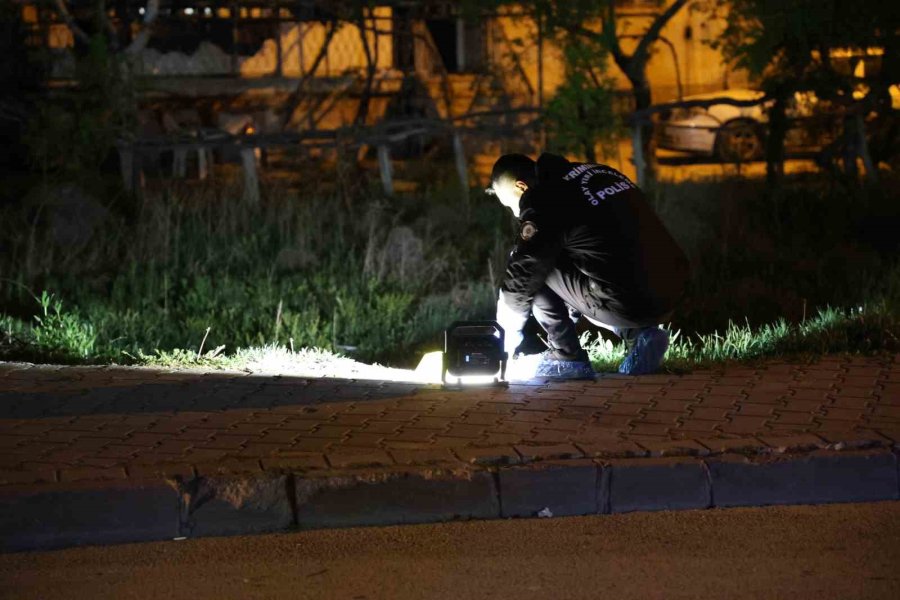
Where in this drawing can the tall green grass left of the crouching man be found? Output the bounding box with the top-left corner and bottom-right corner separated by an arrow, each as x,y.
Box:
0,164 -> 505,362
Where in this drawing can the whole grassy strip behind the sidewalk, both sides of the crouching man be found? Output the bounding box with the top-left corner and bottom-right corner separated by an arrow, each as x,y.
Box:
0,165 -> 900,372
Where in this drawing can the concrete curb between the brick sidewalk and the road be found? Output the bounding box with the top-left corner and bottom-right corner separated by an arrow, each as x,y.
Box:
0,449 -> 900,552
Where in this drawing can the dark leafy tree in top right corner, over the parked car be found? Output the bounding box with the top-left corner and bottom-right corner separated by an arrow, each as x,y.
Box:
708,0 -> 900,184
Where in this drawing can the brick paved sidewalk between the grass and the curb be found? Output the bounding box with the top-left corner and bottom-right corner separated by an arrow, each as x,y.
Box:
0,355 -> 900,486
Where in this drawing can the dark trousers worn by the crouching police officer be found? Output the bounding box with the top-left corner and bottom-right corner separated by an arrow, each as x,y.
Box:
532,269 -> 671,354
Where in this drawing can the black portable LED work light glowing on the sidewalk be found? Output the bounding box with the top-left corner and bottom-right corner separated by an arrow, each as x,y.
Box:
441,321 -> 508,386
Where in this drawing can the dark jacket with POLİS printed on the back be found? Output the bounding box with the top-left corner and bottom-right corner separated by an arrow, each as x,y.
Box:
502,154 -> 689,320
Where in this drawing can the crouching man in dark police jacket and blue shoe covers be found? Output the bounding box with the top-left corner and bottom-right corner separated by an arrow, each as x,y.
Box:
486,154 -> 689,377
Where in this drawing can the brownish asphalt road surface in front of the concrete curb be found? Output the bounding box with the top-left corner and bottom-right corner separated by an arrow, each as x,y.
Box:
0,502 -> 900,600
